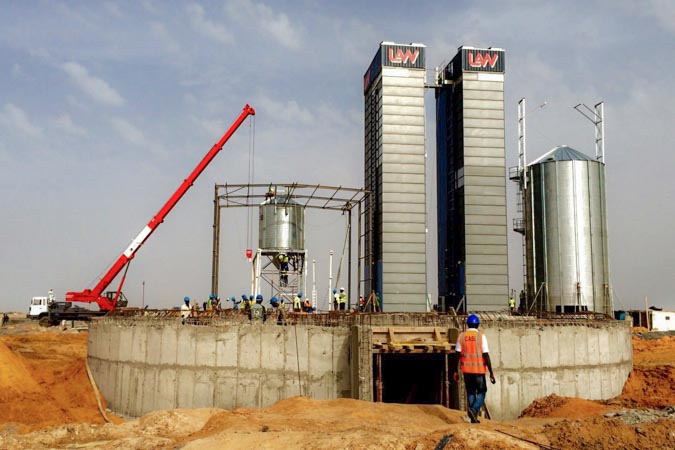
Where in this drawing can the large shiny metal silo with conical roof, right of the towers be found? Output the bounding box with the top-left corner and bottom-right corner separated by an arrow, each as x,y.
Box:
525,146 -> 612,314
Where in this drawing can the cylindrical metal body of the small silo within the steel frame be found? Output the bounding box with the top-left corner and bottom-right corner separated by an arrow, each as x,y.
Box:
258,198 -> 305,251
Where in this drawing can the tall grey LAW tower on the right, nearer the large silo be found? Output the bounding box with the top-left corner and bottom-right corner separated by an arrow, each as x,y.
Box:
436,46 -> 509,311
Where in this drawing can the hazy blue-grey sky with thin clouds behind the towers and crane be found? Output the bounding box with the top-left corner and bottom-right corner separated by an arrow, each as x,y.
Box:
0,0 -> 675,311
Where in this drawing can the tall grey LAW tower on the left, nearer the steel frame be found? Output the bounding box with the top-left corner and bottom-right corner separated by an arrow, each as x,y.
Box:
363,42 -> 428,312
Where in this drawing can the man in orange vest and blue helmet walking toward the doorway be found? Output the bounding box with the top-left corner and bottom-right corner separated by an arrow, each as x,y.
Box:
454,314 -> 496,423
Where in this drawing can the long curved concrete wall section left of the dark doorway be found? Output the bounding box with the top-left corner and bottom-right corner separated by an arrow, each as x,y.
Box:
88,319 -> 352,417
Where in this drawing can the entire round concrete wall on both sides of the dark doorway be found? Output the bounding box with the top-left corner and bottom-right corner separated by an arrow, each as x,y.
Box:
88,315 -> 632,420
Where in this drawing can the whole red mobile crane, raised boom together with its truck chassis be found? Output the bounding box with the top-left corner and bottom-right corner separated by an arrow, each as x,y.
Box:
29,105 -> 255,326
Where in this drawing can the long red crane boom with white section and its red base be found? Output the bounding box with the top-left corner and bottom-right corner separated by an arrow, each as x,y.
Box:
66,105 -> 255,311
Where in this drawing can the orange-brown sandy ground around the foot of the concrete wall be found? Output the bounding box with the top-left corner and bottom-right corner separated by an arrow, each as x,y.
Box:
0,321 -> 675,450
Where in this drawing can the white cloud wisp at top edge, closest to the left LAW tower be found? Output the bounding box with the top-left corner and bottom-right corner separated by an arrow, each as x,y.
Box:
227,0 -> 301,49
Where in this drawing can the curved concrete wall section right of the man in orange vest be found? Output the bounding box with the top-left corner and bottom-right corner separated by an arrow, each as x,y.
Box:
483,321 -> 633,420
